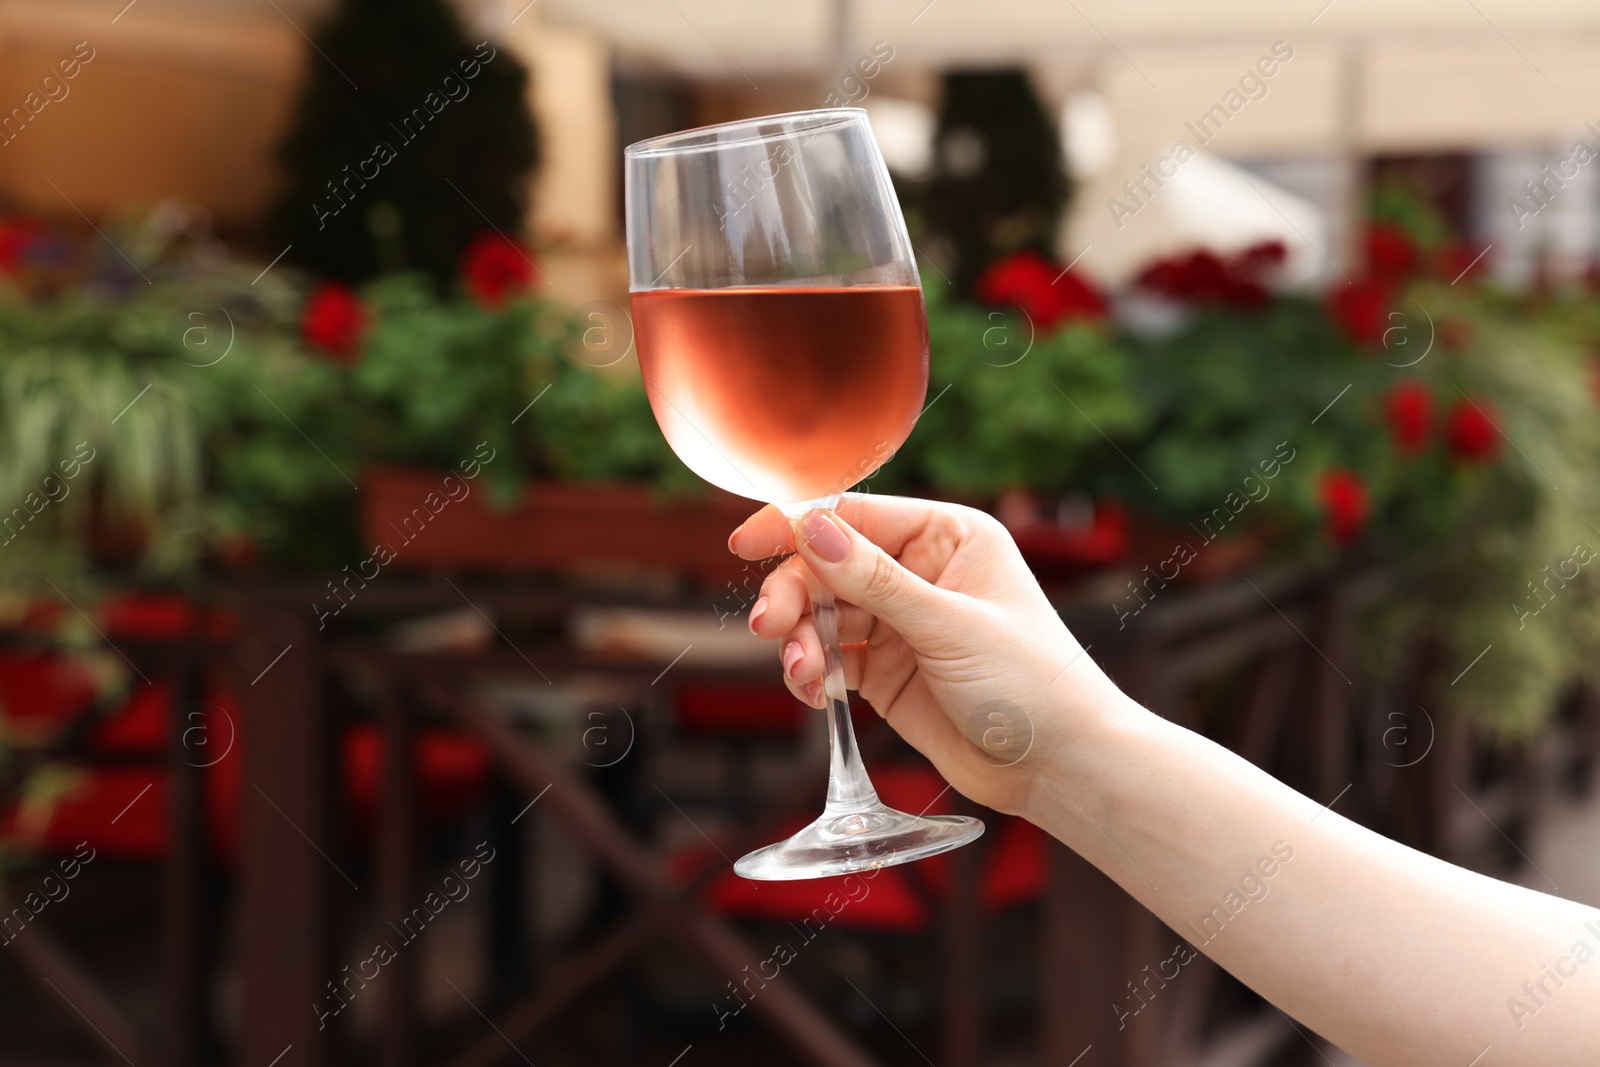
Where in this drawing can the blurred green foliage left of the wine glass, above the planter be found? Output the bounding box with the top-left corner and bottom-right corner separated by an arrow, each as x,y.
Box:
0,215 -> 684,587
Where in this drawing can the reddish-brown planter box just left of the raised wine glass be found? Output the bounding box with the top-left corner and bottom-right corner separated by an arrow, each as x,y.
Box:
362,467 -> 760,584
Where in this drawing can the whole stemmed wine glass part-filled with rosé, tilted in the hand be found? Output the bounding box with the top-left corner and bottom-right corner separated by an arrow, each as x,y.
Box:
626,107 -> 984,880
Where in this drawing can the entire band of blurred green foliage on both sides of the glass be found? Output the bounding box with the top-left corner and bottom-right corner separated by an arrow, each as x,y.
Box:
0,214 -> 1600,731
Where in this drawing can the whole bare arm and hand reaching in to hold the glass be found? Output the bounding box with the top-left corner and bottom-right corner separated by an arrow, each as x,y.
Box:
728,496 -> 1600,1067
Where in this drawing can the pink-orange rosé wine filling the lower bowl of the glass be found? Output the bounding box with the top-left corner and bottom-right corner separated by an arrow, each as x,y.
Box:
632,285 -> 928,504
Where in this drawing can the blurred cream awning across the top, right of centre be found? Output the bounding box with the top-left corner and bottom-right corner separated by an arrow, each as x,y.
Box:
544,0 -> 1600,157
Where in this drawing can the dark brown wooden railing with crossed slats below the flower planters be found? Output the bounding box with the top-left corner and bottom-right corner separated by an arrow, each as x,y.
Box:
3,571 -> 1600,1067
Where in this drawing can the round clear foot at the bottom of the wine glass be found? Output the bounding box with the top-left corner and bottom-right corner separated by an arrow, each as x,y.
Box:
733,805 -> 984,881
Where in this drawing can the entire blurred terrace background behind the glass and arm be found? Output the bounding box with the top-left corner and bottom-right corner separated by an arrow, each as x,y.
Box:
0,0 -> 1600,1067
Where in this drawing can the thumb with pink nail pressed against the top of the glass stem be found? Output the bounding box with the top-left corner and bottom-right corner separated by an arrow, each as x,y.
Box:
795,509 -> 949,645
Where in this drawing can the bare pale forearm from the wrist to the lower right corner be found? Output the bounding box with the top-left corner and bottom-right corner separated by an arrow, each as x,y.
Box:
1026,702 -> 1600,1067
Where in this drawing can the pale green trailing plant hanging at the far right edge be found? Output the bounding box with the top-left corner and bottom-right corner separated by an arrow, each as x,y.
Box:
1433,283 -> 1600,734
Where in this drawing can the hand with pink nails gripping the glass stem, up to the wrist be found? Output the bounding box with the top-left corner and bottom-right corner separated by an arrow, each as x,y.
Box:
728,494 -> 1125,813
